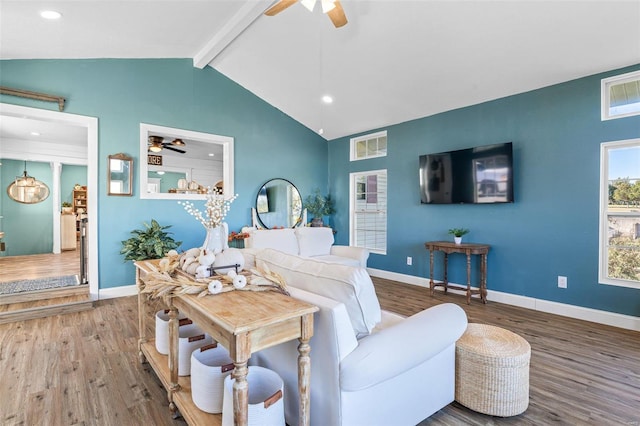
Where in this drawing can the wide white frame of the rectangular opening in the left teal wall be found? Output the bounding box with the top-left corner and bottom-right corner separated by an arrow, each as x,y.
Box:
138,123 -> 235,200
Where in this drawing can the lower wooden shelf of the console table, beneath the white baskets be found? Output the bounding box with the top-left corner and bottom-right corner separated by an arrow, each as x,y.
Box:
140,339 -> 222,426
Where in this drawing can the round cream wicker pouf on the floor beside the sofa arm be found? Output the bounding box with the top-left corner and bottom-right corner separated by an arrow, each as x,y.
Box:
456,324 -> 531,417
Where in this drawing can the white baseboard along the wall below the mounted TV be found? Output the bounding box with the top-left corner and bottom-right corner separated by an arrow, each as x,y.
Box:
367,268 -> 640,331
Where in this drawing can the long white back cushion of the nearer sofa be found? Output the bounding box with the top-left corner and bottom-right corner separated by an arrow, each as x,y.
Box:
256,249 -> 382,338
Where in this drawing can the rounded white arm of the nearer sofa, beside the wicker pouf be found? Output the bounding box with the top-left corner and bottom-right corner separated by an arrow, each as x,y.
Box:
340,303 -> 467,391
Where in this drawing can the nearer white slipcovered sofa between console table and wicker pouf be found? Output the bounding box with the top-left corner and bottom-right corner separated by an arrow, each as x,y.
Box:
245,250 -> 467,426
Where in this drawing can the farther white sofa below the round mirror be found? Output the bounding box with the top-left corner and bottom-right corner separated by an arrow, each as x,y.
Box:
243,226 -> 369,268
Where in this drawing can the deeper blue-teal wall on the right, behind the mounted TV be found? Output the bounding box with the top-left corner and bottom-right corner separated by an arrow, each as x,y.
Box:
329,66 -> 640,316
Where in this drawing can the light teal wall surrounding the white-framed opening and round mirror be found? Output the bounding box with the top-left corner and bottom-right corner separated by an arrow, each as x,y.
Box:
0,59 -> 328,288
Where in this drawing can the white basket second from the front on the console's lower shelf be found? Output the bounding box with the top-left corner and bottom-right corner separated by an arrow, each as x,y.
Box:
191,343 -> 234,413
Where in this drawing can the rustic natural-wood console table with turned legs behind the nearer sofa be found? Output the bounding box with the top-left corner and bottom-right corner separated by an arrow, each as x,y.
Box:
135,261 -> 318,425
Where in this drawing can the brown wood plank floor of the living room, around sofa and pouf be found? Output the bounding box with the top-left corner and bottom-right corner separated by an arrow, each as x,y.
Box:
0,279 -> 640,426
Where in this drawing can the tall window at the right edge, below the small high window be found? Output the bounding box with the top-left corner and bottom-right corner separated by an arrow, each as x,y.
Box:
599,139 -> 640,288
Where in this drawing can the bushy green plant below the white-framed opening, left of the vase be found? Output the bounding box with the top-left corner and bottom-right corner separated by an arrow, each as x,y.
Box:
120,219 -> 182,260
